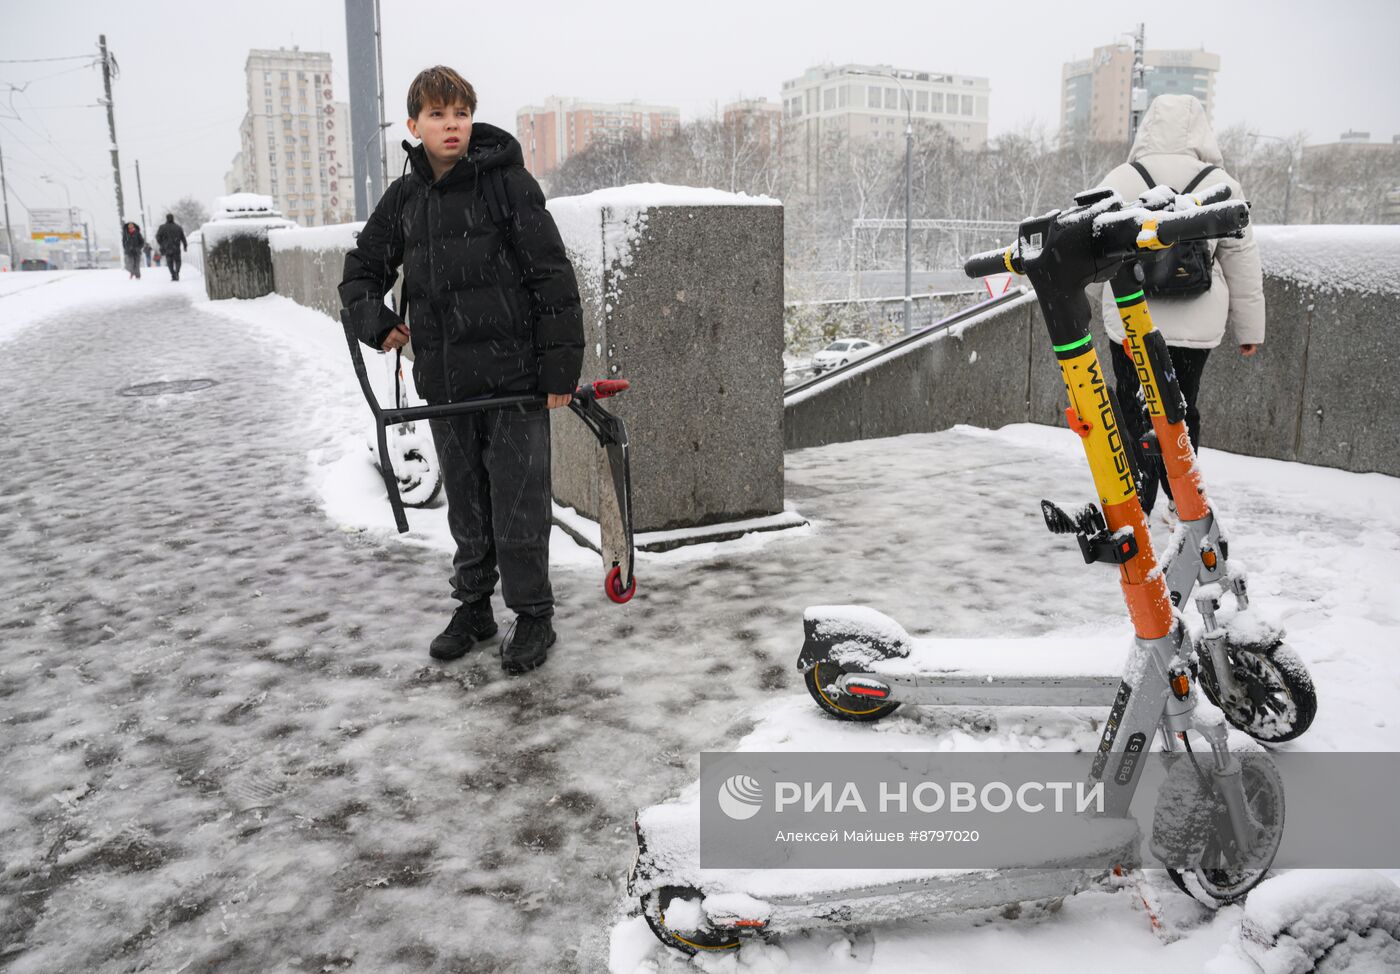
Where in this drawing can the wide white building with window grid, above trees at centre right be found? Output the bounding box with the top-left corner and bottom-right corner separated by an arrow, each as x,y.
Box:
783,64 -> 991,190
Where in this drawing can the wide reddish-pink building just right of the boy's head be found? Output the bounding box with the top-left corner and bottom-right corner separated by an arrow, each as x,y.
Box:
515,97 -> 680,176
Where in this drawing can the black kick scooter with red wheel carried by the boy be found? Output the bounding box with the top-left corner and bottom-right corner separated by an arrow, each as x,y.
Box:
340,311 -> 637,603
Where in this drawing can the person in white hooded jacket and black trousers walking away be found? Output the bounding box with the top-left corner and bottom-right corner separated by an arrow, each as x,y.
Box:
1100,95 -> 1264,511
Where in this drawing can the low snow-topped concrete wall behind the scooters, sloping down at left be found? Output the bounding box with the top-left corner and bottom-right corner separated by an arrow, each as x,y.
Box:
785,227 -> 1400,476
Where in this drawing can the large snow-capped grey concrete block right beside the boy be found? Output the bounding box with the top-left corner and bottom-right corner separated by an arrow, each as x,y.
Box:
550,186 -> 783,532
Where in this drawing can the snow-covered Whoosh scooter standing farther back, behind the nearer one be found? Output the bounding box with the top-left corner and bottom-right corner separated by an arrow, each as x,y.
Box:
798,185 -> 1317,743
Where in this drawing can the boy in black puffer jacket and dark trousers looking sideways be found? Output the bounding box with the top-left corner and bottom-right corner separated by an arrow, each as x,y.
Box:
340,66 -> 584,673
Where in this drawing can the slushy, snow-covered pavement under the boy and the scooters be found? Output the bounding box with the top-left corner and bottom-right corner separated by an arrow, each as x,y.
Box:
0,271 -> 1400,974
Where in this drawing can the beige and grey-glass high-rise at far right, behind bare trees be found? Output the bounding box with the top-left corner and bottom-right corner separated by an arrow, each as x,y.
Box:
1060,41 -> 1221,141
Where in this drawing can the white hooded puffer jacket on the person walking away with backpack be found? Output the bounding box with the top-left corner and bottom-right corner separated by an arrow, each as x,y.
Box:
1102,95 -> 1264,348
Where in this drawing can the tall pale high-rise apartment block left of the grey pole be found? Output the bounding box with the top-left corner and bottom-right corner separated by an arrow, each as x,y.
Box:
224,46 -> 354,227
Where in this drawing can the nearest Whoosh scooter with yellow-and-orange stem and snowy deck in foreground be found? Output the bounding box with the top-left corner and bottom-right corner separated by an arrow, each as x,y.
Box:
629,181 -> 1282,953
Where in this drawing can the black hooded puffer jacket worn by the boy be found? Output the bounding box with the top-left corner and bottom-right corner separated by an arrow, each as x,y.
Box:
340,122 -> 584,403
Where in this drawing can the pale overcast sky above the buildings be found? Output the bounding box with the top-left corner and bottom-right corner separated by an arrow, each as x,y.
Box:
0,0 -> 1400,236
